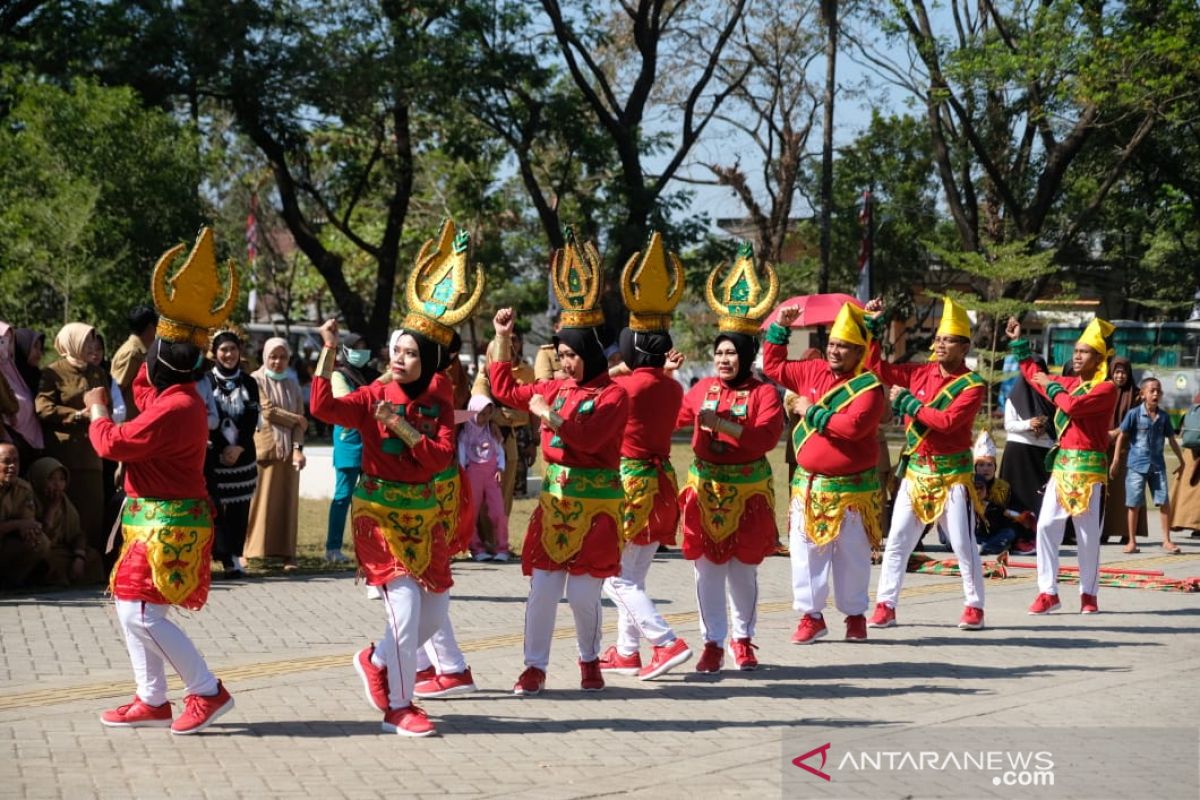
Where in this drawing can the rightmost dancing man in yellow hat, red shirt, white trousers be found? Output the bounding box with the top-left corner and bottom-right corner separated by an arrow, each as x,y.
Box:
1004,319 -> 1117,614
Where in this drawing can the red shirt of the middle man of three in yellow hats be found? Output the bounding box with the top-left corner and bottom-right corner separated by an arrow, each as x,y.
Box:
866,342 -> 986,456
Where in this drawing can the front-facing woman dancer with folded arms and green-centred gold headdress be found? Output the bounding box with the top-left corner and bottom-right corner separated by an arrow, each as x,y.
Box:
674,246 -> 784,673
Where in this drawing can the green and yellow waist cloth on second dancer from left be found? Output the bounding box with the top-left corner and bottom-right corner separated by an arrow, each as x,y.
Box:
350,473 -> 443,577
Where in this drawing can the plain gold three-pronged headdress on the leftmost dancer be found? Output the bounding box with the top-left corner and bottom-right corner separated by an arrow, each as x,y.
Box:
150,228 -> 238,350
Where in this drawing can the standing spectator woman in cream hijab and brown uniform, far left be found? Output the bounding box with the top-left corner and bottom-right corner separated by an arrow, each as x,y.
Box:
35,323 -> 109,553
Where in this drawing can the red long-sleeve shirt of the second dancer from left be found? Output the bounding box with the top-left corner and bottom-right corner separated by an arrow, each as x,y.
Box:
308,373 -> 455,483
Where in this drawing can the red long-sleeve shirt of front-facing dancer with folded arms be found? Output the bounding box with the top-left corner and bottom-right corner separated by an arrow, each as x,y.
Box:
676,375 -> 784,464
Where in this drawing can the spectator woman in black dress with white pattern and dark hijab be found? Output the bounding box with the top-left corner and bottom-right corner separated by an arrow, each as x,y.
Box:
206,331 -> 260,578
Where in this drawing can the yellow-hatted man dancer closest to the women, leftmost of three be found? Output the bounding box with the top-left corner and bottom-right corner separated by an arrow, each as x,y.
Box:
762,303 -> 884,644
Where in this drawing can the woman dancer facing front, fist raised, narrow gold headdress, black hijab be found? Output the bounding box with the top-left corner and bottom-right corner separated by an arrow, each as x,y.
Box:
488,230 -> 629,696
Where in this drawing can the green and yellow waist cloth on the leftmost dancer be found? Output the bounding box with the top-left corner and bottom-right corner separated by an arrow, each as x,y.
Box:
108,498 -> 212,606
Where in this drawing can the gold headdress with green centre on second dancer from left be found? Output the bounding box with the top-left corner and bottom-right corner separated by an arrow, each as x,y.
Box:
401,219 -> 486,347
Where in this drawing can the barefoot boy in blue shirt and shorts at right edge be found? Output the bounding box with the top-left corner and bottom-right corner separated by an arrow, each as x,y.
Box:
1109,378 -> 1183,554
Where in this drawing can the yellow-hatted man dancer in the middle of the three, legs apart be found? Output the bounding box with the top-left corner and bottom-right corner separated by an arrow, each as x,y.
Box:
866,297 -> 986,631
